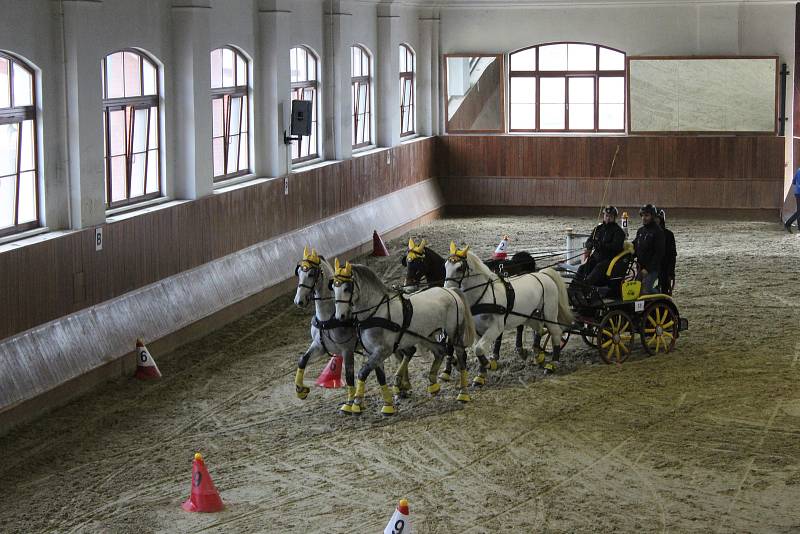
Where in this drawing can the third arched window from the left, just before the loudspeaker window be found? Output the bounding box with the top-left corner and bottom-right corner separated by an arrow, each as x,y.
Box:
211,46 -> 250,181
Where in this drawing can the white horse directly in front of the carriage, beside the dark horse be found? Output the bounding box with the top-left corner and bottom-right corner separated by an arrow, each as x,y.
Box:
444,243 -> 574,385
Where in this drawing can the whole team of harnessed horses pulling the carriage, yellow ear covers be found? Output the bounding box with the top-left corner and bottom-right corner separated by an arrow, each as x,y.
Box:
294,240 -> 573,415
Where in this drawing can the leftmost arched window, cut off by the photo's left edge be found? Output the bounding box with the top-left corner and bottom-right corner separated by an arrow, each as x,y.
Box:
0,53 -> 39,236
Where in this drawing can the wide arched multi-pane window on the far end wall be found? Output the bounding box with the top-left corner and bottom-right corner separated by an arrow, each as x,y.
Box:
509,43 -> 625,132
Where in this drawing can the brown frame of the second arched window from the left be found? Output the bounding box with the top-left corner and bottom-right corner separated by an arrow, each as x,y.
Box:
101,48 -> 164,211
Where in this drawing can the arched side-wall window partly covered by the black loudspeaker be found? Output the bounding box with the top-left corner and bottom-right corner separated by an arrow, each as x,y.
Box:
289,46 -> 319,163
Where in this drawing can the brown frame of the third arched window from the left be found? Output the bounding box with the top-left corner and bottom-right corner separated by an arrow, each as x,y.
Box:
209,45 -> 253,183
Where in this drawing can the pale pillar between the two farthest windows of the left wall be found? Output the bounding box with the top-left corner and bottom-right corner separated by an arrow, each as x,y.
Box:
375,5 -> 400,147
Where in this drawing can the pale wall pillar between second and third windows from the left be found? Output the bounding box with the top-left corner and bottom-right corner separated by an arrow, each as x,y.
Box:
168,0 -> 214,199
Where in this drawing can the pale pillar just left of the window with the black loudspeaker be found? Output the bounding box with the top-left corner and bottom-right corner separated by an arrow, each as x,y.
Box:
255,0 -> 291,177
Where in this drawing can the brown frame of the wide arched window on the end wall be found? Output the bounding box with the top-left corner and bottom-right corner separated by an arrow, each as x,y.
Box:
507,41 -> 628,134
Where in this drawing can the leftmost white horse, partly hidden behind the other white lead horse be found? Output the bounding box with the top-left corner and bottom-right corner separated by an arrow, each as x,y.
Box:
294,248 -> 394,415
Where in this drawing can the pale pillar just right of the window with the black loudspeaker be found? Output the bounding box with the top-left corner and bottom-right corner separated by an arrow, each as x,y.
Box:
323,0 -> 353,160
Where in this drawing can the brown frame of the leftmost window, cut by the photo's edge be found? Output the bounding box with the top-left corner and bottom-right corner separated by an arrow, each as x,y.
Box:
0,51 -> 42,238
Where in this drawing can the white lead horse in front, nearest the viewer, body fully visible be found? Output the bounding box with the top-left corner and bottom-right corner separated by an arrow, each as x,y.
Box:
332,260 -> 476,415
